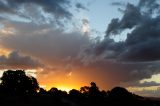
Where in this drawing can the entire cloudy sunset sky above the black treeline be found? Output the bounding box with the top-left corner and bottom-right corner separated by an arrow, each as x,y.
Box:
0,0 -> 160,97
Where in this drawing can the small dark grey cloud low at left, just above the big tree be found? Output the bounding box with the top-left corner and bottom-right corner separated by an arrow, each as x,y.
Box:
0,51 -> 43,69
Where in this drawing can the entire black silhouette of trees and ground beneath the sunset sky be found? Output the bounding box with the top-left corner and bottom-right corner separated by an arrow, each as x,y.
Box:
0,70 -> 160,106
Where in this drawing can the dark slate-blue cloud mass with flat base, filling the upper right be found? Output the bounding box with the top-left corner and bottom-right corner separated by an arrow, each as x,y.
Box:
87,0 -> 160,61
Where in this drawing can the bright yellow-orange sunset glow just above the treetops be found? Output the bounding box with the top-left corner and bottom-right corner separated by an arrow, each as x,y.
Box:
37,68 -> 89,92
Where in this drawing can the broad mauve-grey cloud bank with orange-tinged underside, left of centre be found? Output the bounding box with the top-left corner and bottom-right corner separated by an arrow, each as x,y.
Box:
0,22 -> 89,70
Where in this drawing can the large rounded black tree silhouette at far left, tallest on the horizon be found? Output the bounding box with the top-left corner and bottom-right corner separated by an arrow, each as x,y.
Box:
1,70 -> 39,95
